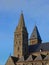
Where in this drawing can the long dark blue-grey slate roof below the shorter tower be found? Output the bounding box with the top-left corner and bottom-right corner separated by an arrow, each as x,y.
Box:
28,42 -> 49,53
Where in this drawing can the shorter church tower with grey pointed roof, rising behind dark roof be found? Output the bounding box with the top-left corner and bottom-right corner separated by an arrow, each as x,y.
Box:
30,25 -> 42,45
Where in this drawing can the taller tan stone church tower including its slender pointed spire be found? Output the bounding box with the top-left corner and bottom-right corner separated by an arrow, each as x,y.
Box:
14,13 -> 28,58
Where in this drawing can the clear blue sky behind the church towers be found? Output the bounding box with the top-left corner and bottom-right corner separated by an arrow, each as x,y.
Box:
0,0 -> 49,65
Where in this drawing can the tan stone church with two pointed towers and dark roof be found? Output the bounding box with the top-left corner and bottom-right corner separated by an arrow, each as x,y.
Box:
5,13 -> 49,65
